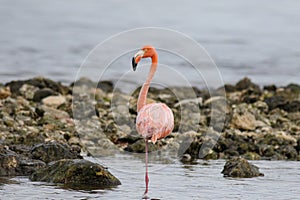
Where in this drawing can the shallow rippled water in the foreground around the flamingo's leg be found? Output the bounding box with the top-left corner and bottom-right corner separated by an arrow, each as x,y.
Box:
0,155 -> 300,200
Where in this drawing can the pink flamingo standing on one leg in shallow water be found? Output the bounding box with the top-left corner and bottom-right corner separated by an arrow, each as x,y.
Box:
132,45 -> 174,199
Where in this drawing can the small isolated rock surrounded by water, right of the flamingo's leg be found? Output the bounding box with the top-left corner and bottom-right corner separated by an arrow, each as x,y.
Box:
221,158 -> 264,178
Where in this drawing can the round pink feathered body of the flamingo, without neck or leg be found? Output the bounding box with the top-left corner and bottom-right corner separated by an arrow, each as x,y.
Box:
136,103 -> 174,143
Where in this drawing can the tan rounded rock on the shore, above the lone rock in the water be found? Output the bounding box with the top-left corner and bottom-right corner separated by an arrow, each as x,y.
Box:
231,112 -> 257,130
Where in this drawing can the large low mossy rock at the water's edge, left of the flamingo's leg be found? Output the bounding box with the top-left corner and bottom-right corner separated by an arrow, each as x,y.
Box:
29,159 -> 121,189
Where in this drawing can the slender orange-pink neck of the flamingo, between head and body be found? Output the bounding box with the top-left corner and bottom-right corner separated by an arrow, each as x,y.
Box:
137,52 -> 158,112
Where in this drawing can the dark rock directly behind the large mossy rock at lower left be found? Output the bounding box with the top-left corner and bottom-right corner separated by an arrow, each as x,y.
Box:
30,142 -> 82,163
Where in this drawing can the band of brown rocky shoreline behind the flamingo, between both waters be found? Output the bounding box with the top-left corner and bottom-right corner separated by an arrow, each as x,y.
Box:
0,77 -> 300,185
